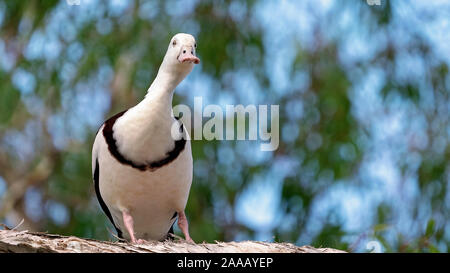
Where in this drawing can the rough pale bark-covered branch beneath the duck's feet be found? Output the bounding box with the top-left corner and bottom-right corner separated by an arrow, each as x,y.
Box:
0,230 -> 344,253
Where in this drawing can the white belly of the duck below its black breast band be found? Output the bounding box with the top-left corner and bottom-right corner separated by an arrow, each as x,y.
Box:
96,131 -> 193,240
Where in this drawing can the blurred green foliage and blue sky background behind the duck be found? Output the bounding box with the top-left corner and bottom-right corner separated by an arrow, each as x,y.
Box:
0,0 -> 450,252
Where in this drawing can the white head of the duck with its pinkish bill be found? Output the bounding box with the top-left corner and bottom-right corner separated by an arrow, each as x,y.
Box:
162,33 -> 200,73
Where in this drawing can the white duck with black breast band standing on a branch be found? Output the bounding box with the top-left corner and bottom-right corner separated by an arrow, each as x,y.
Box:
92,33 -> 200,243
